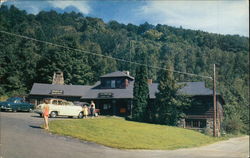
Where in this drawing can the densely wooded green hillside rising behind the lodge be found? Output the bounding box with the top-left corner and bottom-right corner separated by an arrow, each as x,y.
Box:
0,5 -> 249,131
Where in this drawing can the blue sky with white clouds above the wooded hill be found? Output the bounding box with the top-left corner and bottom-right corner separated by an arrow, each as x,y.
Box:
1,0 -> 249,37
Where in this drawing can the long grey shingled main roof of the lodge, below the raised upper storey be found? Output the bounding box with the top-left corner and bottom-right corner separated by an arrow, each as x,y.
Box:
30,81 -> 213,99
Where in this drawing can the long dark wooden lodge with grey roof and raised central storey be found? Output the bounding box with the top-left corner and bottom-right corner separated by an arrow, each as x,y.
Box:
29,71 -> 224,128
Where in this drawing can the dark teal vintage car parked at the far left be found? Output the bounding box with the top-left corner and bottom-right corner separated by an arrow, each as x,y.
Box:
0,97 -> 34,112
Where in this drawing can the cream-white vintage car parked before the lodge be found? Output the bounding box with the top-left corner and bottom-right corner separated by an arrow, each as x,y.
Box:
34,98 -> 83,118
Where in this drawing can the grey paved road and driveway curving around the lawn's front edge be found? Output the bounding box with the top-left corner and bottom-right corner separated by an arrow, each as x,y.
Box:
0,112 -> 249,158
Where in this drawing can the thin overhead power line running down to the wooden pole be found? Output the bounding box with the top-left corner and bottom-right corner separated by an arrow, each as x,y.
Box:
0,30 -> 212,79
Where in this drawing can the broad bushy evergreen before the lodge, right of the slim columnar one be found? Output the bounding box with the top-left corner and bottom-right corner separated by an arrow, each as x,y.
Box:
154,63 -> 188,126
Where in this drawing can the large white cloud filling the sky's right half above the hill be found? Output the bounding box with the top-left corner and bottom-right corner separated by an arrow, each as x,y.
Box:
135,0 -> 249,36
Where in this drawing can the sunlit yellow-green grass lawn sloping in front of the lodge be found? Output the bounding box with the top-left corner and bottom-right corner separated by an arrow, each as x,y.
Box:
50,117 -> 225,149
